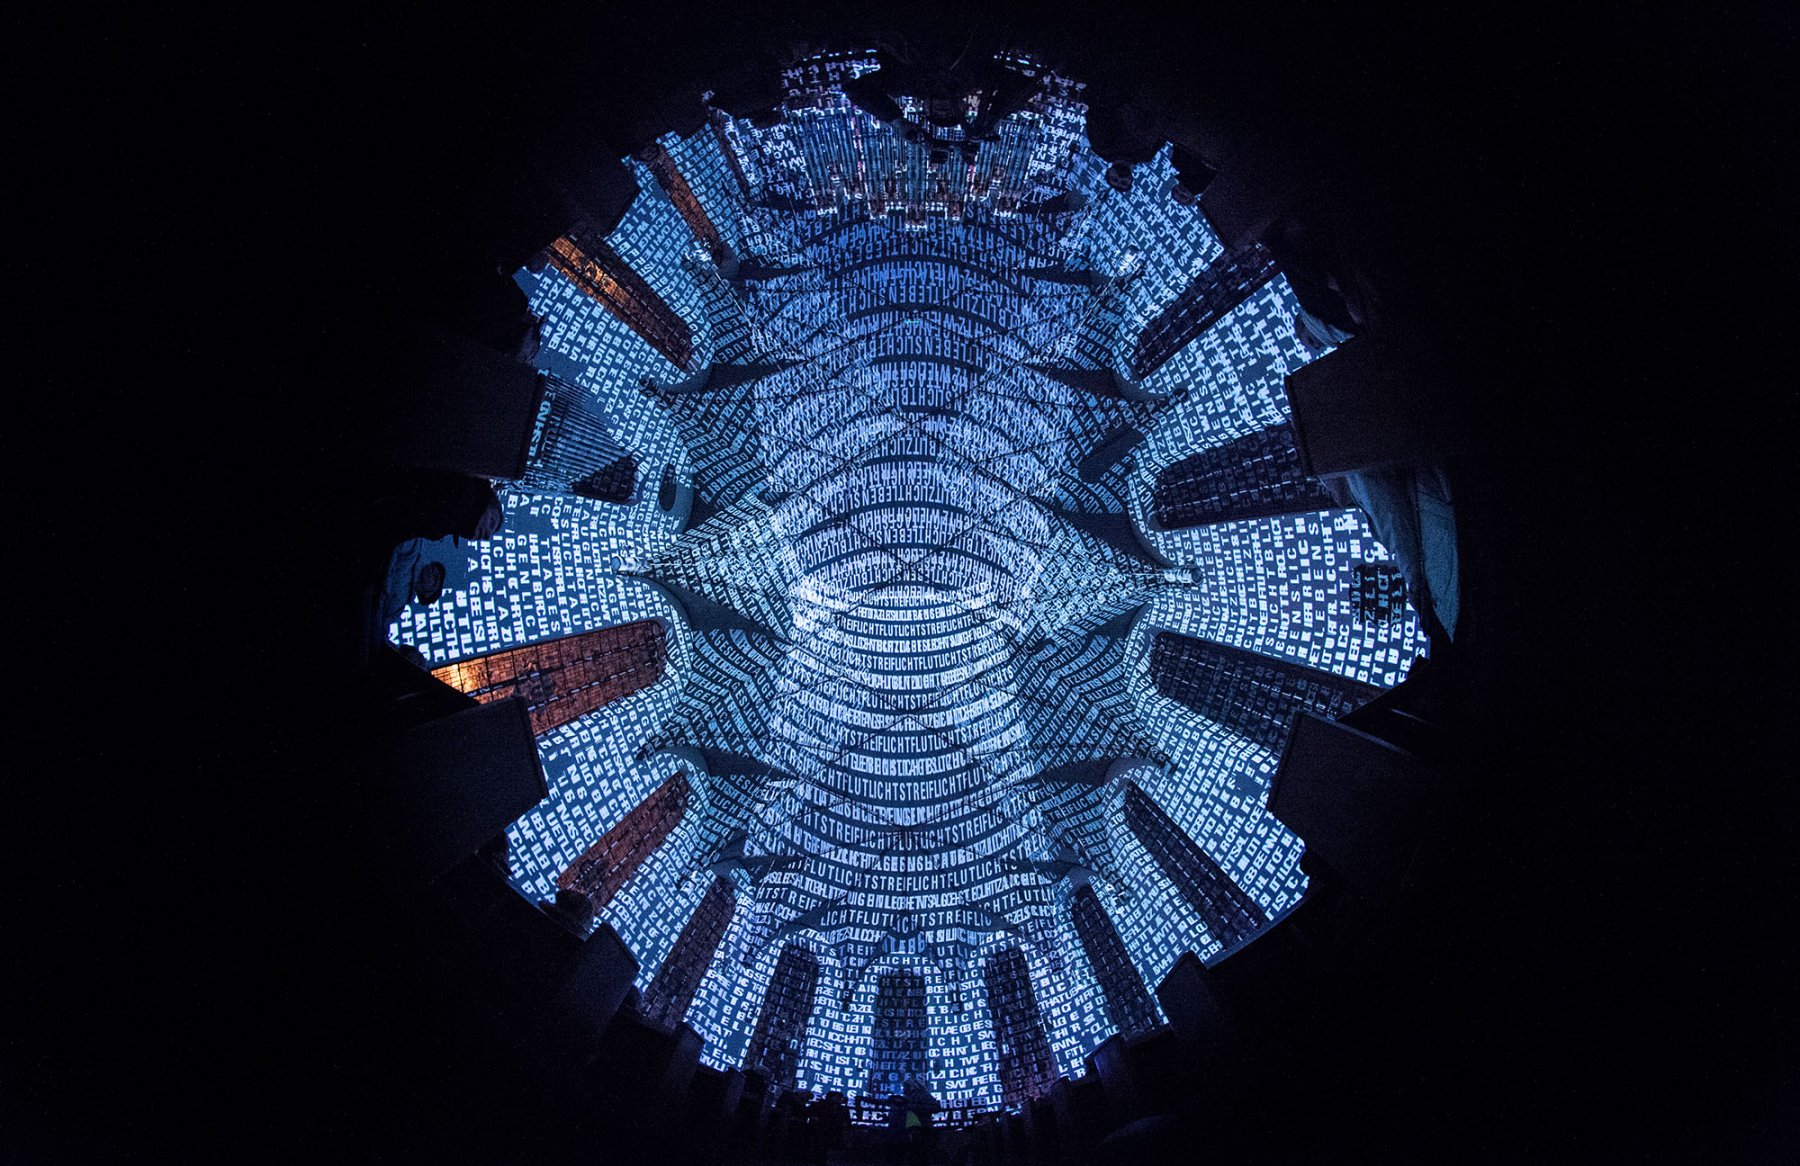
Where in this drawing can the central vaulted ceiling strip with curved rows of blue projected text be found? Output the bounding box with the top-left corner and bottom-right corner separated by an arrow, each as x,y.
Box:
643,209 -> 1184,993
